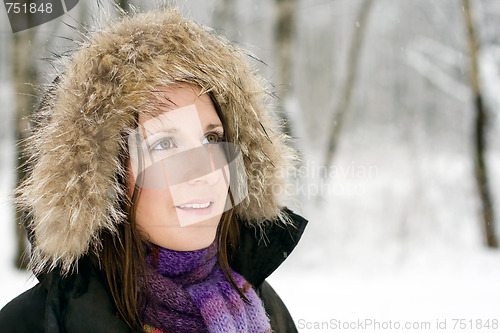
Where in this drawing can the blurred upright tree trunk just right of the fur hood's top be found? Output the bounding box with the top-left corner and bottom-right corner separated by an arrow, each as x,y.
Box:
274,0 -> 297,135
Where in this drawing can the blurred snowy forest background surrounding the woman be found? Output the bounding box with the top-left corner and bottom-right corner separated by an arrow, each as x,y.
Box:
0,0 -> 500,332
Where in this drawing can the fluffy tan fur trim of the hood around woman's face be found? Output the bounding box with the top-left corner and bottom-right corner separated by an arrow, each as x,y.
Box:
16,10 -> 295,272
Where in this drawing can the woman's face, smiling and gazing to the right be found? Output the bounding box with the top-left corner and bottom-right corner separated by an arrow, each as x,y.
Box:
127,84 -> 229,251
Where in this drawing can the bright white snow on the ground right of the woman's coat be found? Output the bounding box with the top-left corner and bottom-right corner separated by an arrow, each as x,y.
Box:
269,243 -> 500,332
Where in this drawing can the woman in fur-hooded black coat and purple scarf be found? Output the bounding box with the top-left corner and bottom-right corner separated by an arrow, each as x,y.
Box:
0,10 -> 307,332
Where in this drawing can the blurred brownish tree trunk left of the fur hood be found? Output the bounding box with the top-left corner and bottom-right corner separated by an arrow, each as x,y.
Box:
12,29 -> 35,269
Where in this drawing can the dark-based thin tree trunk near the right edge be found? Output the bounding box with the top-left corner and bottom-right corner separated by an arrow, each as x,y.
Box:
462,0 -> 498,248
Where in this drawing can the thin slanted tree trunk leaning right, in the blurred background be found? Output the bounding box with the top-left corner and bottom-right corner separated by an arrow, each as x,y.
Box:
324,0 -> 373,170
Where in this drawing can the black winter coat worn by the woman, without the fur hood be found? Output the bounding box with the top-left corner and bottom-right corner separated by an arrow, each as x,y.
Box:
0,210 -> 307,333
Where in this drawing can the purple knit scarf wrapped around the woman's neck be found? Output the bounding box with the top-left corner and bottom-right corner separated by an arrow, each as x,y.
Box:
143,242 -> 271,333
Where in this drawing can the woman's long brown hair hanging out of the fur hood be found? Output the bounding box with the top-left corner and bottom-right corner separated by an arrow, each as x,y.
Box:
99,94 -> 245,330
